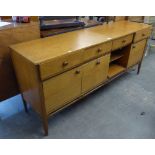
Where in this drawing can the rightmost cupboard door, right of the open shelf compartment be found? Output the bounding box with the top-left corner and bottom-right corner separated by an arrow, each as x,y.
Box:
128,39 -> 146,67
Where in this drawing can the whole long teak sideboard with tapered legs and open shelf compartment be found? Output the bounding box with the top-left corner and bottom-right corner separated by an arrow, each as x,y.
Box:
11,21 -> 151,135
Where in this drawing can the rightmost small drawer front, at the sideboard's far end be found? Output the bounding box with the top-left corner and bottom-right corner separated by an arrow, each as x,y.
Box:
134,29 -> 151,42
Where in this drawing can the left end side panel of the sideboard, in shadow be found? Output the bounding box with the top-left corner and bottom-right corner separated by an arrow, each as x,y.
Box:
11,51 -> 43,114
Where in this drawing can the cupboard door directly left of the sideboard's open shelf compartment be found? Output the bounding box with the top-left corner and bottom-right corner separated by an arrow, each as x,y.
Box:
82,54 -> 110,93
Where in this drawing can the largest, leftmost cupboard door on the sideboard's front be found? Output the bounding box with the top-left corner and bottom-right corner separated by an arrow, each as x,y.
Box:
43,67 -> 81,114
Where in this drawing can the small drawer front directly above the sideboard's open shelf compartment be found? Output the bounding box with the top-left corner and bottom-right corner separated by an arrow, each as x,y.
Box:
112,34 -> 133,51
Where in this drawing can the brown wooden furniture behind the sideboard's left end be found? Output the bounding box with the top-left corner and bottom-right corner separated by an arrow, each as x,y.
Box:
0,20 -> 40,101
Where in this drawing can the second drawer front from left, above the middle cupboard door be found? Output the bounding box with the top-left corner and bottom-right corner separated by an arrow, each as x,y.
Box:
83,41 -> 112,61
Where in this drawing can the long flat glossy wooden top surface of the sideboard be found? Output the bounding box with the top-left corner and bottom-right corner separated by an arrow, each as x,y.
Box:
11,21 -> 151,64
